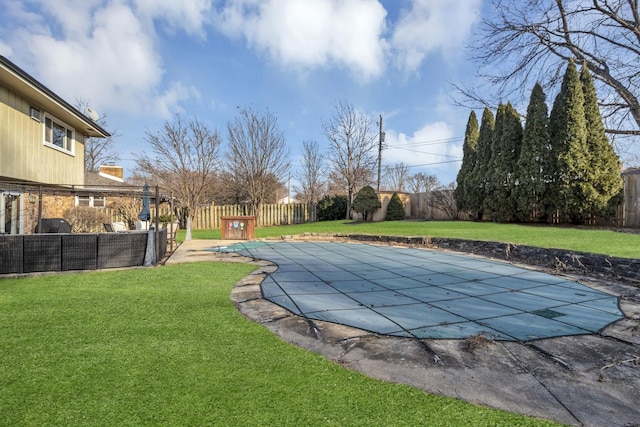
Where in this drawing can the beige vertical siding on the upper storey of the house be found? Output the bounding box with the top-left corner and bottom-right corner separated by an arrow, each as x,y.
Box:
0,86 -> 84,185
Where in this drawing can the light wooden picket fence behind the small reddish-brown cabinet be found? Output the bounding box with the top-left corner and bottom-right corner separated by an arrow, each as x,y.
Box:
191,203 -> 309,230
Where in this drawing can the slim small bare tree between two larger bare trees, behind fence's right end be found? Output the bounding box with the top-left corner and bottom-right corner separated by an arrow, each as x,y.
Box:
294,141 -> 324,222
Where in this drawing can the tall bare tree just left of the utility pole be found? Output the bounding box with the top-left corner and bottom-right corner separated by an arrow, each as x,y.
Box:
322,101 -> 378,219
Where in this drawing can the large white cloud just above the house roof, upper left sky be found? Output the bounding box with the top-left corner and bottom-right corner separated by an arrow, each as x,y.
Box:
23,4 -> 162,112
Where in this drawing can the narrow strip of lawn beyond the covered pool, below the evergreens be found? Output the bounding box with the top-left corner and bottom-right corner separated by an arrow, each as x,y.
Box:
179,221 -> 640,258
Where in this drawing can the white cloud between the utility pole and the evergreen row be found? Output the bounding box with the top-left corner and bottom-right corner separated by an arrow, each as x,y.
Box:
382,122 -> 462,184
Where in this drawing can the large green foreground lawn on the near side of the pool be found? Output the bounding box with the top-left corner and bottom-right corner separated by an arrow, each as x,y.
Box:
0,263 -> 554,426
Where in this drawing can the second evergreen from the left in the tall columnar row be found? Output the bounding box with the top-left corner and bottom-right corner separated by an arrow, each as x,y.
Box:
464,107 -> 495,220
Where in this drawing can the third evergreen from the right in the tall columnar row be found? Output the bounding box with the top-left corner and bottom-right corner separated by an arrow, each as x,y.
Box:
516,83 -> 551,221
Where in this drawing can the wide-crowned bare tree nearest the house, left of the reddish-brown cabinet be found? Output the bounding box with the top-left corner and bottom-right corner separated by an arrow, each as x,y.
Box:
136,116 -> 221,240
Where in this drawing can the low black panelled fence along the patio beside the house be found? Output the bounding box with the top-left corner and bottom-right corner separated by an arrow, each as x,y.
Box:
0,228 -> 167,274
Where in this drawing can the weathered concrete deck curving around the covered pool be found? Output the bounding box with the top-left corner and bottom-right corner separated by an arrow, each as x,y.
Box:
167,240 -> 640,426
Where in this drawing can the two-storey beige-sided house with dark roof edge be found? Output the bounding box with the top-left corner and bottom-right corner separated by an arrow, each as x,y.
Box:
0,56 -> 109,234
